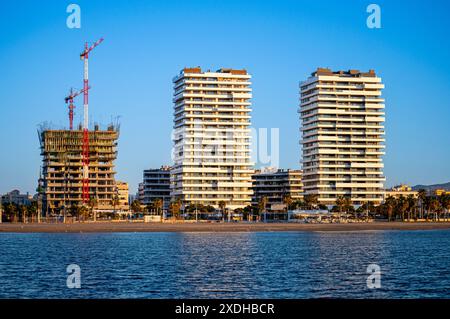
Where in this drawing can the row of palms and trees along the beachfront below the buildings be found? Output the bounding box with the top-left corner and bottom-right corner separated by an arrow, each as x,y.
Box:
1,189 -> 450,223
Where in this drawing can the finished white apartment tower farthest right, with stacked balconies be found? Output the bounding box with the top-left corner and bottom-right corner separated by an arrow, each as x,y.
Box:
299,68 -> 385,205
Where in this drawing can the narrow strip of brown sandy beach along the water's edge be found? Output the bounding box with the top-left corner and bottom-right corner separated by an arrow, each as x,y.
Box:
0,222 -> 450,233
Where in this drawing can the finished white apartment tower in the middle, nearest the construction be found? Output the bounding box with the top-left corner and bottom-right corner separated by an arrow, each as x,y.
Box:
171,67 -> 253,209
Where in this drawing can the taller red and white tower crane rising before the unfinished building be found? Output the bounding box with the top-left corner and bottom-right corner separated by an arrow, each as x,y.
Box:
80,38 -> 103,204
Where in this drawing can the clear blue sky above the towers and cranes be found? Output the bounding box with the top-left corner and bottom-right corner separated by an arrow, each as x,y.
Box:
0,0 -> 450,193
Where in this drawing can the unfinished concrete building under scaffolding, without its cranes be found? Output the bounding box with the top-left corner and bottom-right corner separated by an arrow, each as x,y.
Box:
38,124 -> 119,215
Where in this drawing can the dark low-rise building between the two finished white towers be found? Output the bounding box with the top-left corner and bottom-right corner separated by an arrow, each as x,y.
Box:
252,168 -> 303,211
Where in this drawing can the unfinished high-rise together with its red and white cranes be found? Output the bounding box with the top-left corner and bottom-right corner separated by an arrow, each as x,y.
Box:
38,39 -> 119,216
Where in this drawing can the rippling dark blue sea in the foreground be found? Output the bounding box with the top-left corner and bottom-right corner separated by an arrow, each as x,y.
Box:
0,230 -> 450,298
